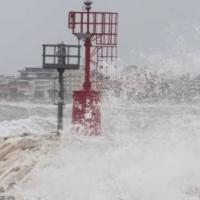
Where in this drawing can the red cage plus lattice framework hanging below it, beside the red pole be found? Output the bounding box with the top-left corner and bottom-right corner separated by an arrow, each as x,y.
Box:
68,11 -> 118,89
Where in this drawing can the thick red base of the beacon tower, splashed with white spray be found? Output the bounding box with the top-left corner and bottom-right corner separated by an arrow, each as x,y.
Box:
72,89 -> 101,135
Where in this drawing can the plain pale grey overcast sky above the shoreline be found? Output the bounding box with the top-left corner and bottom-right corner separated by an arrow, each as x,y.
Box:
0,0 -> 200,75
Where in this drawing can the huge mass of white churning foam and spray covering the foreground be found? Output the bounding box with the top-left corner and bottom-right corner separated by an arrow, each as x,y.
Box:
10,102 -> 200,200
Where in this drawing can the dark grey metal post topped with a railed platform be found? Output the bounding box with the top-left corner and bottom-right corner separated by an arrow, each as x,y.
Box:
42,42 -> 81,135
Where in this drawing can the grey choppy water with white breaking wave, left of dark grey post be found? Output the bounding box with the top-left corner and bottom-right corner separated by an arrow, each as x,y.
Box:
0,102 -> 60,137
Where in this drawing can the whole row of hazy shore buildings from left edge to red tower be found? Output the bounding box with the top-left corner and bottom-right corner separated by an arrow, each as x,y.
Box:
0,67 -> 85,102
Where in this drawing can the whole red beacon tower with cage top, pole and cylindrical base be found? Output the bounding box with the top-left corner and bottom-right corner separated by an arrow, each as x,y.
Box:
68,0 -> 118,135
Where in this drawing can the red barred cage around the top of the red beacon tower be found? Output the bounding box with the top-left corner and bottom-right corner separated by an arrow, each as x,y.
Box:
68,12 -> 118,45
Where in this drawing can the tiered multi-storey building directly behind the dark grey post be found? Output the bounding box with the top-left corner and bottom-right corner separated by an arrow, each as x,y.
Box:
18,67 -> 84,101
